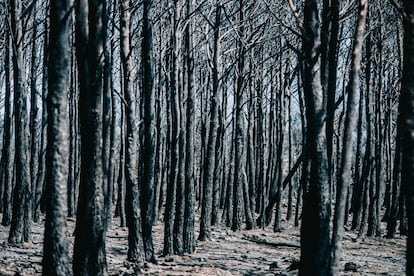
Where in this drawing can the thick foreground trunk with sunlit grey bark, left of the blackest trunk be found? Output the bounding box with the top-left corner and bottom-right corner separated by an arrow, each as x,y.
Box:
42,0 -> 72,275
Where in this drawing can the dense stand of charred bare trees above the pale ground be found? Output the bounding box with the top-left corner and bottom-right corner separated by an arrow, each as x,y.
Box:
0,0 -> 414,275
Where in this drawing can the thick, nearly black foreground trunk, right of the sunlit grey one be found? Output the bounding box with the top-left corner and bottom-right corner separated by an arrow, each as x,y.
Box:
73,0 -> 107,275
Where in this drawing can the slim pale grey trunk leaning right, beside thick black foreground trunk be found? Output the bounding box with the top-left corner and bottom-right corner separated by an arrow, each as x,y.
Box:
331,0 -> 368,275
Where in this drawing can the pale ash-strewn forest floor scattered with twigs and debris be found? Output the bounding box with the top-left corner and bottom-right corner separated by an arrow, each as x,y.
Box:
0,210 -> 406,275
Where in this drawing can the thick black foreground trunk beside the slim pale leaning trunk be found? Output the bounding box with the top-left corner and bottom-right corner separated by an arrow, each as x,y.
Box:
299,0 -> 331,275
